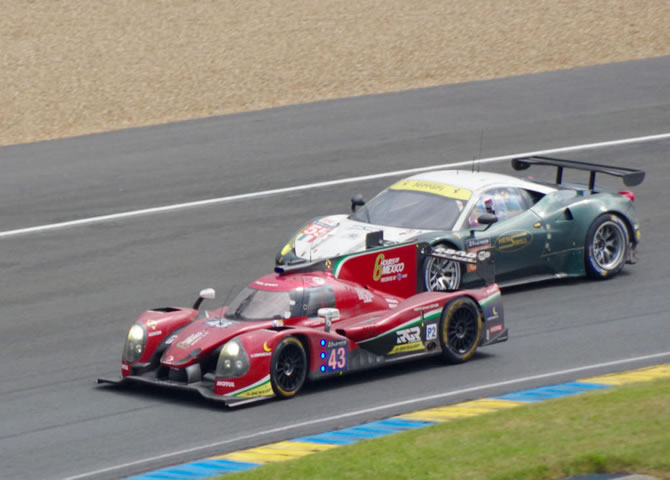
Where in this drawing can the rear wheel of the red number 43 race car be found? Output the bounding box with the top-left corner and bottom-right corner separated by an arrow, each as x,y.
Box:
440,297 -> 483,363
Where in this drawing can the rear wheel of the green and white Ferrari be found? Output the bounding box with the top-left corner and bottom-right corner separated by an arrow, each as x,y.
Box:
584,213 -> 629,279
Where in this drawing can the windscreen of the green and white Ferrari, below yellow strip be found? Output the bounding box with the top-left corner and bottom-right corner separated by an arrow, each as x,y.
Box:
350,190 -> 465,230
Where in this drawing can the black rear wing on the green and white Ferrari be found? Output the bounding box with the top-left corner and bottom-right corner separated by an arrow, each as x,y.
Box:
512,156 -> 644,191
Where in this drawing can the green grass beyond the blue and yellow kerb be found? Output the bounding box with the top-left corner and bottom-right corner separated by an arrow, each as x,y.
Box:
221,380 -> 670,480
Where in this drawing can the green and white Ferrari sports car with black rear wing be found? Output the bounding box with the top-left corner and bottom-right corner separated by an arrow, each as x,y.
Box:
276,157 -> 644,290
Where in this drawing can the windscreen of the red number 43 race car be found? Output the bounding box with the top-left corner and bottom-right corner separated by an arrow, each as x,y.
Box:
225,287 -> 302,320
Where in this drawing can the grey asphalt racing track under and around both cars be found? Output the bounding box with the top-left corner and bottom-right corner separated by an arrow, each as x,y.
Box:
0,57 -> 670,479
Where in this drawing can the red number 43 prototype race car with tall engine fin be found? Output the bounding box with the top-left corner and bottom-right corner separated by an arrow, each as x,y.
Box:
98,243 -> 508,406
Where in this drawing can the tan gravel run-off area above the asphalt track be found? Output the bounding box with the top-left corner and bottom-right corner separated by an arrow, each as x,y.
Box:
0,0 -> 670,145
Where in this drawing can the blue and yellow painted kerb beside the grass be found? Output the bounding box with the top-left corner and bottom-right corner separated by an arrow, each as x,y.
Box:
128,363 -> 670,480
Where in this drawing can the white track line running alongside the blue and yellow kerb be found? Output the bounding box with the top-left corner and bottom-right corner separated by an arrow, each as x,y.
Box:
65,352 -> 670,480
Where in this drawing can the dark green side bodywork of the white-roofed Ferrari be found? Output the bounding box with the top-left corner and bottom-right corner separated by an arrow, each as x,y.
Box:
419,189 -> 640,284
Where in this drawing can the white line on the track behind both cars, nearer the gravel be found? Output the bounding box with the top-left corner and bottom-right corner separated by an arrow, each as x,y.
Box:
0,133 -> 670,238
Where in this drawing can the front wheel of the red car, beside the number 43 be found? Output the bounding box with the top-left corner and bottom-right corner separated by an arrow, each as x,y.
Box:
270,337 -> 308,398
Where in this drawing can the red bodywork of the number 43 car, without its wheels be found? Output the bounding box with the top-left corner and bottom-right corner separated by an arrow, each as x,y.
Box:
101,244 -> 507,405
